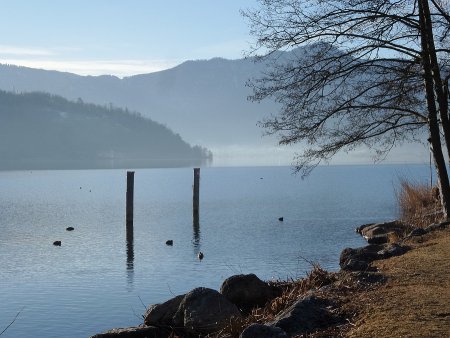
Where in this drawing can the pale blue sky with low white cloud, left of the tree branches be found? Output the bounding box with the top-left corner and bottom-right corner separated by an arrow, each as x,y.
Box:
0,0 -> 256,77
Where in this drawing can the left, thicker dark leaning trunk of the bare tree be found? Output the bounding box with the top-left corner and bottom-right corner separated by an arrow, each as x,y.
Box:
418,0 -> 450,219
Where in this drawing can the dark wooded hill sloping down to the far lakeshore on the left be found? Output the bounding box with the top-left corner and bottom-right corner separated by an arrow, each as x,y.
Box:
0,91 -> 212,170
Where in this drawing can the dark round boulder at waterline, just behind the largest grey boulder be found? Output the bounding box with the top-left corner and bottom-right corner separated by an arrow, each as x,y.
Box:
220,274 -> 276,313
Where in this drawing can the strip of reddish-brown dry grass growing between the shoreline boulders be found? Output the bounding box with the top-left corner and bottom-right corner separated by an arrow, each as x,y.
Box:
210,264 -> 336,338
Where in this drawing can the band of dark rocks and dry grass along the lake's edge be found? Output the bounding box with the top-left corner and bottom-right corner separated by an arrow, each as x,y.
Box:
91,221 -> 450,338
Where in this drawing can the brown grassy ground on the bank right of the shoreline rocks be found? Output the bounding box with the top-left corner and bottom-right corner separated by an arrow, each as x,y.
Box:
339,229 -> 450,337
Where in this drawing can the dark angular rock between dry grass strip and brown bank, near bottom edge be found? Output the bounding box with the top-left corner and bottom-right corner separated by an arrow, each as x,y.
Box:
268,294 -> 340,336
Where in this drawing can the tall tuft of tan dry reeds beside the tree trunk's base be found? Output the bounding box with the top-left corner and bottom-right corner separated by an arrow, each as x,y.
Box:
396,179 -> 442,228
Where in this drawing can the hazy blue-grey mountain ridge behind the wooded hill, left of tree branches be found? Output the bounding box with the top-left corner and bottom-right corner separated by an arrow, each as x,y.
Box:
0,54 -> 278,147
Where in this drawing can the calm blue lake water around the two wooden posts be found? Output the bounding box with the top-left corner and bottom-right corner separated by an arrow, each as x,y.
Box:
0,165 -> 429,338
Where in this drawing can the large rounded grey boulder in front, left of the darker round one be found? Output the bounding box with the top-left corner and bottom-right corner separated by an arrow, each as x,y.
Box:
174,288 -> 241,334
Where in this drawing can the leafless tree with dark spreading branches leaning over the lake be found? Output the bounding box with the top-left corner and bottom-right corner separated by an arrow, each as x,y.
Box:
243,0 -> 450,218
